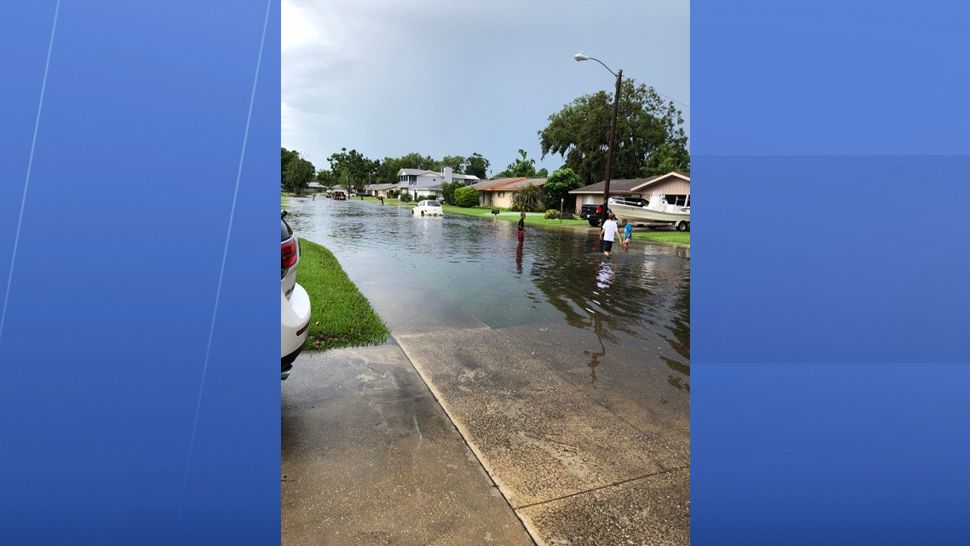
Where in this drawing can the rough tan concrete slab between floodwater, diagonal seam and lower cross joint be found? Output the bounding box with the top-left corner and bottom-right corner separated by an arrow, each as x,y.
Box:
398,328 -> 689,508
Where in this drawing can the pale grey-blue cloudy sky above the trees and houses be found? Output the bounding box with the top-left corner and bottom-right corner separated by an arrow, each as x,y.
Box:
281,0 -> 690,174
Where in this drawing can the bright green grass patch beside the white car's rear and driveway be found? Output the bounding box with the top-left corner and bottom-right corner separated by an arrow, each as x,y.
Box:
296,239 -> 388,351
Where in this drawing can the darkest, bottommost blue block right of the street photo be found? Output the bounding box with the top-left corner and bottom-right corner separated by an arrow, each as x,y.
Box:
691,362 -> 970,545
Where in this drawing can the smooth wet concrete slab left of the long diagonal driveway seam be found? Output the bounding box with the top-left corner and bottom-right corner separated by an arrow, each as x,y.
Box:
281,345 -> 533,545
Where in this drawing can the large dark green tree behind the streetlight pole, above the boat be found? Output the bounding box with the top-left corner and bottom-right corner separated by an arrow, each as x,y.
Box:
539,80 -> 690,184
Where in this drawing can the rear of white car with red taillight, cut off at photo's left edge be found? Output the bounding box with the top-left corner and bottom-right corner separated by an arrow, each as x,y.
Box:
280,211 -> 310,379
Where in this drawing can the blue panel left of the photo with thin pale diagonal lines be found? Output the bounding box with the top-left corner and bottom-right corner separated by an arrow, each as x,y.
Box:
0,0 -> 280,544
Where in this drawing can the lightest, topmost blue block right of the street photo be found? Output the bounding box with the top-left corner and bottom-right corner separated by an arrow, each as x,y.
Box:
691,0 -> 970,155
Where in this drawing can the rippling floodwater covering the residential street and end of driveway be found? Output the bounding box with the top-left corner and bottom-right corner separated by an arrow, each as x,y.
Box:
287,198 -> 690,394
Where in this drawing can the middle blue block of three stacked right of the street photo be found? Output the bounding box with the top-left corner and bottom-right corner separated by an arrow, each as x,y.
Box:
691,155 -> 970,363
